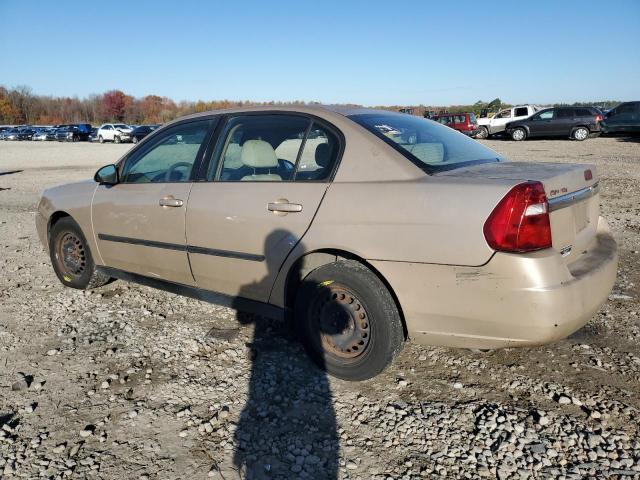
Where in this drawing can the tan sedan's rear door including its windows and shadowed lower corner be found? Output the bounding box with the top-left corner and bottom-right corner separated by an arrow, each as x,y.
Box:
187,113 -> 340,302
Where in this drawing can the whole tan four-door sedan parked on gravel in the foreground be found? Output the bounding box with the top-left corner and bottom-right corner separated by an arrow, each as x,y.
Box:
37,107 -> 617,380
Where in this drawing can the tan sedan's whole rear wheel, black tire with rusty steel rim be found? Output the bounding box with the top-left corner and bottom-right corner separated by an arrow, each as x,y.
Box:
294,260 -> 404,381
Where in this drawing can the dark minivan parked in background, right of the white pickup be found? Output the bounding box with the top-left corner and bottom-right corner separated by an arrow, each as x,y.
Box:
506,107 -> 602,141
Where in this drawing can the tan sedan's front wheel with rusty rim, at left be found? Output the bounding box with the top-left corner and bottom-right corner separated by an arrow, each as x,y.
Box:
49,217 -> 111,290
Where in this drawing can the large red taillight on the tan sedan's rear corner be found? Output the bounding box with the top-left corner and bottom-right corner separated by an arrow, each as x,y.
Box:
484,182 -> 551,252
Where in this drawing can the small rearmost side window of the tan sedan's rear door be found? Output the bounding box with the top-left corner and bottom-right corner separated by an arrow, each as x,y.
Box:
295,122 -> 340,181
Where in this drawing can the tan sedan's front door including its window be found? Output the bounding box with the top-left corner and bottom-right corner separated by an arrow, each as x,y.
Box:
91,120 -> 214,285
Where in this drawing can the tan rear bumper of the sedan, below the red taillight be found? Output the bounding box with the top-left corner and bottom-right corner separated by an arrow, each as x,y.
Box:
371,218 -> 618,348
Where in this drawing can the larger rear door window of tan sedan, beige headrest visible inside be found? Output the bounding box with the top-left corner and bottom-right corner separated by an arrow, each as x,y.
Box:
207,114 -> 311,182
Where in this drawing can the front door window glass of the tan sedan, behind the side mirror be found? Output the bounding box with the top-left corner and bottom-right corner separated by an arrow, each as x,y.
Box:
121,120 -> 211,183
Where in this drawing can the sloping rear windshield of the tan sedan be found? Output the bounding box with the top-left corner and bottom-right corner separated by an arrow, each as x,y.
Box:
349,113 -> 502,173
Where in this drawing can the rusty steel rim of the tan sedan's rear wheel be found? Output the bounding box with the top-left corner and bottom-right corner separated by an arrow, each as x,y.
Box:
312,285 -> 371,360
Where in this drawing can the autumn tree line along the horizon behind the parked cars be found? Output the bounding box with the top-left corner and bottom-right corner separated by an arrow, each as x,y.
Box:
0,86 -> 620,125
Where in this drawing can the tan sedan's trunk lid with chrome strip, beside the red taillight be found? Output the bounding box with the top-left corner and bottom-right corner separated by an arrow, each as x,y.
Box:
436,162 -> 600,263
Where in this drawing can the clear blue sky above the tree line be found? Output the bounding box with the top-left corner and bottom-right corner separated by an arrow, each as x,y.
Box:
0,0 -> 640,105
